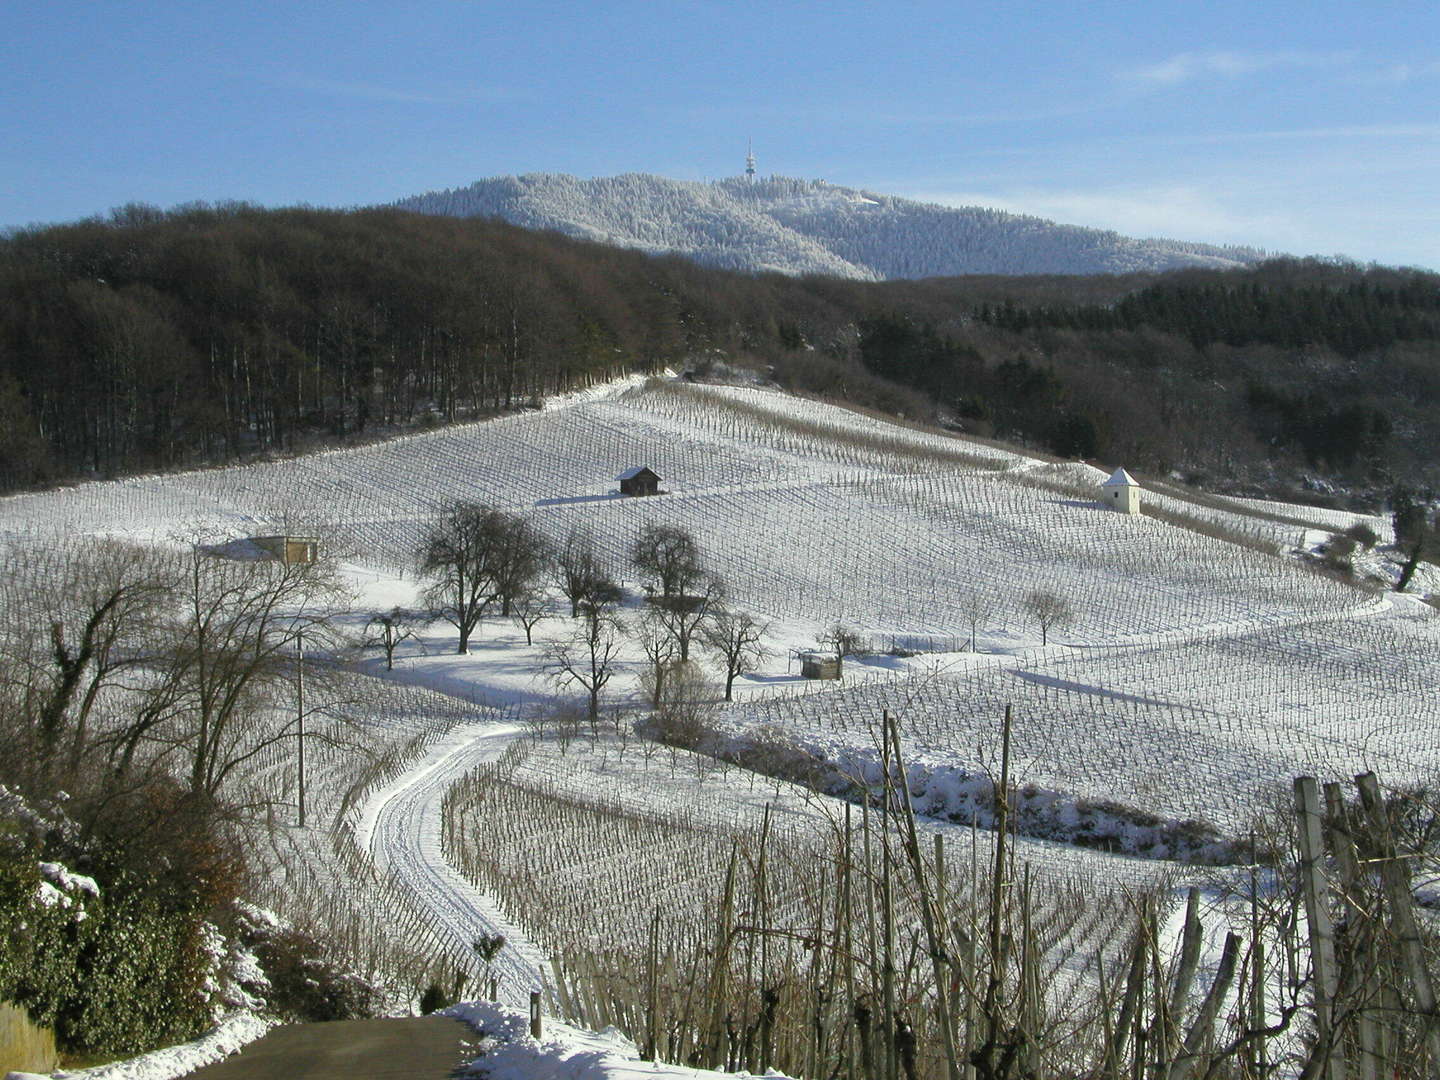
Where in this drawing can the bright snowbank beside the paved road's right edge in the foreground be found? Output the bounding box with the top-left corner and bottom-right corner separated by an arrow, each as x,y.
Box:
444,1002 -> 783,1080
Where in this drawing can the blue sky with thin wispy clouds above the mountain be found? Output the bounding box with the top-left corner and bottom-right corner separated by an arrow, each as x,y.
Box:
0,0 -> 1440,269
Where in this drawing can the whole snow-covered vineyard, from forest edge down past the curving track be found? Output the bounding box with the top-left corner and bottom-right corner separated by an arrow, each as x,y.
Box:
0,380 -> 1440,1077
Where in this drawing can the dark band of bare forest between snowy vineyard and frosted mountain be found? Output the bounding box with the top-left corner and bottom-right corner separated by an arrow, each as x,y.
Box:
0,203 -> 1440,491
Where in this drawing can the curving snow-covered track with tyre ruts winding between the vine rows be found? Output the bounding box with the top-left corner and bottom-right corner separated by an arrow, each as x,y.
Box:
356,721 -> 549,1005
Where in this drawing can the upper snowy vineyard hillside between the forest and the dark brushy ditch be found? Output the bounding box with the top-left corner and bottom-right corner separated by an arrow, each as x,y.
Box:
0,380 -> 1436,852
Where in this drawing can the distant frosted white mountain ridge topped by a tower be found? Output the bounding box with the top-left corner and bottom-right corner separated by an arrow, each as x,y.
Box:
395,173 -> 1266,281
